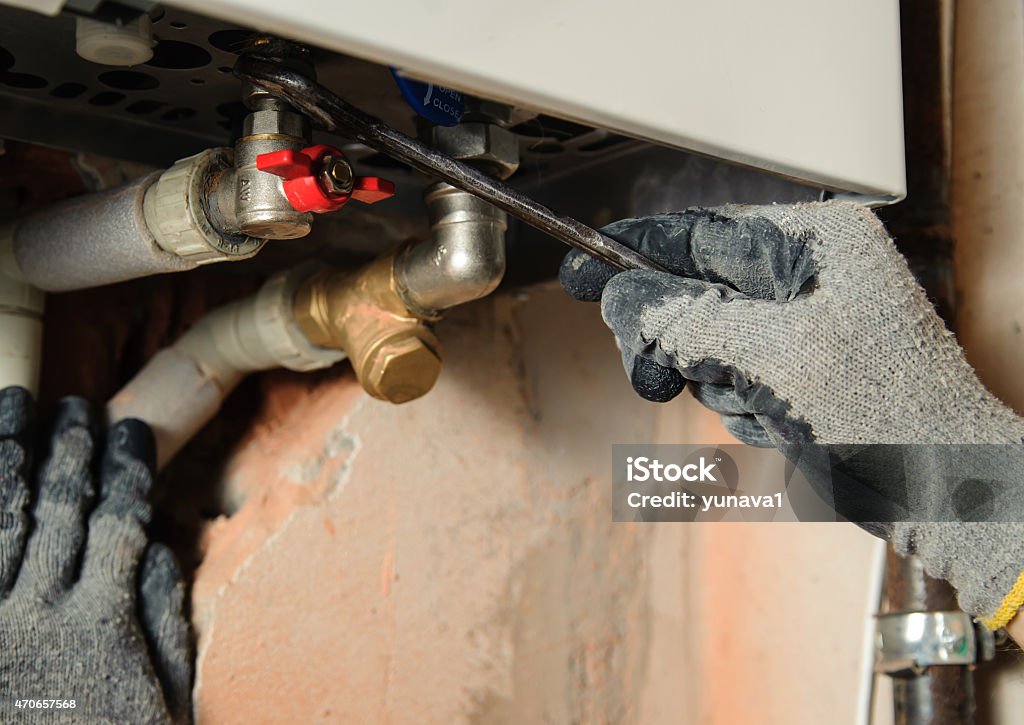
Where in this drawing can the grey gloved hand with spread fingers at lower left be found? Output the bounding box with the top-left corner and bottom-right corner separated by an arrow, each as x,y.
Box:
0,388 -> 191,723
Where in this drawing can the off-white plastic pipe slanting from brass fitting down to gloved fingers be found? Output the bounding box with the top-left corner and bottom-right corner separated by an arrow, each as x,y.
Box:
106,265 -> 345,468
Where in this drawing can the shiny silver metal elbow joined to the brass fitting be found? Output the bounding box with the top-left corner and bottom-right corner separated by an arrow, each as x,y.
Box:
395,183 -> 507,316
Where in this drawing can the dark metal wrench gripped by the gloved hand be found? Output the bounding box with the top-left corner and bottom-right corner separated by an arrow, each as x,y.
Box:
234,55 -> 665,271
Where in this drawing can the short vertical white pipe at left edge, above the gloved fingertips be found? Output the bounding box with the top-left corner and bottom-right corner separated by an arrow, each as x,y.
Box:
0,224 -> 46,397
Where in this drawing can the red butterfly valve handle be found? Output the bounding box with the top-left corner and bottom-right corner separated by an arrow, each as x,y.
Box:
256,143 -> 394,214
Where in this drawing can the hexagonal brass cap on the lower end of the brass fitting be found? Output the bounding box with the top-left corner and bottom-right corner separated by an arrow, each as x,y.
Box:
359,334 -> 441,403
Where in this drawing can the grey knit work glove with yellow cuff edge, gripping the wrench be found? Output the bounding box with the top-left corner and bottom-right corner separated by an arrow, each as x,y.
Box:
560,202 -> 1024,629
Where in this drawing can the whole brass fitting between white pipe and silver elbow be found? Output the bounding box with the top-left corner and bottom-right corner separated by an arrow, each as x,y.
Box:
295,256 -> 441,403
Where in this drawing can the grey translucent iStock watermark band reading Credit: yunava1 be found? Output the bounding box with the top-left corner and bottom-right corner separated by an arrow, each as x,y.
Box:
611,443 -> 1024,525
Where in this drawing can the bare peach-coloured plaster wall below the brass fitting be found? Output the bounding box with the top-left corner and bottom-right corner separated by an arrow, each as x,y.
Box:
194,289 -> 872,724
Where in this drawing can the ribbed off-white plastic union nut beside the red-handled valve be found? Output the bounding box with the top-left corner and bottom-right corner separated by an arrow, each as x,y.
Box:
142,148 -> 266,264
